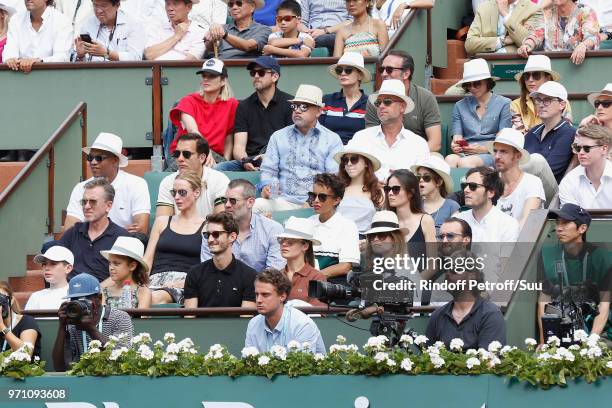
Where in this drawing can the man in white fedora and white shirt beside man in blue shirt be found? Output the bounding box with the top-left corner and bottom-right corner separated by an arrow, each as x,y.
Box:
352,79 -> 429,180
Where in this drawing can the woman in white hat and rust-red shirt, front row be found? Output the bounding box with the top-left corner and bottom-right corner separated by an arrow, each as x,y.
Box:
277,217 -> 326,306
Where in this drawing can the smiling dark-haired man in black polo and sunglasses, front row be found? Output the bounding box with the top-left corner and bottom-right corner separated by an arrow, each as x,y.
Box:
185,212 -> 257,308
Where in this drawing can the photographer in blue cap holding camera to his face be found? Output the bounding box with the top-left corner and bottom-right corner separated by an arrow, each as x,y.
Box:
53,273 -> 134,371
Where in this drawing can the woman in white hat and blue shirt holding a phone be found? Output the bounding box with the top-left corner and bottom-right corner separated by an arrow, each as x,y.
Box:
446,58 -> 512,168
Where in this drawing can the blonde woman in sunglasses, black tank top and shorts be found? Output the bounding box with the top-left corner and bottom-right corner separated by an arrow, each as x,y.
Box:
144,171 -> 206,304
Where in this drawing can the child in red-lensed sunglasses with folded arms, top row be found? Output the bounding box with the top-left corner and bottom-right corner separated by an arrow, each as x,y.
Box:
263,0 -> 315,58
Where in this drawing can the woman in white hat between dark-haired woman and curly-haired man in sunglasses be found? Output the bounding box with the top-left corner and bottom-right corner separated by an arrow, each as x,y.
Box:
410,153 -> 460,235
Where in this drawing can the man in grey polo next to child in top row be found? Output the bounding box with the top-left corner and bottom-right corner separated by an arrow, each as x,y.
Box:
204,0 -> 272,60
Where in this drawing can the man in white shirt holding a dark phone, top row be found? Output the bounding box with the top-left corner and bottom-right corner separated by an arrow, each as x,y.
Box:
74,0 -> 145,61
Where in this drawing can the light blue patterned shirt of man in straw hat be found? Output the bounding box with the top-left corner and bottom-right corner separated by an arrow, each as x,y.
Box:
261,122 -> 342,204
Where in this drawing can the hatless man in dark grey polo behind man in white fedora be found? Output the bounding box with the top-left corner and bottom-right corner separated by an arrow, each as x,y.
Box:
365,50 -> 442,152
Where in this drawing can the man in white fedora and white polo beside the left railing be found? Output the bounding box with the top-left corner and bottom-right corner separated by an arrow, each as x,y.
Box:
64,133 -> 151,234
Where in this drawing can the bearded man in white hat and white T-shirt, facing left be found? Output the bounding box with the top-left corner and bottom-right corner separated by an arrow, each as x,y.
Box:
487,128 -> 546,227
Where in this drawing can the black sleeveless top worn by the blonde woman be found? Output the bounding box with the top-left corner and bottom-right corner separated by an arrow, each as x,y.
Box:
151,217 -> 206,275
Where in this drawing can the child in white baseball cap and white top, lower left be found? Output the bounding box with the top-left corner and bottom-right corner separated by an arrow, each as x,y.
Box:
25,245 -> 74,310
